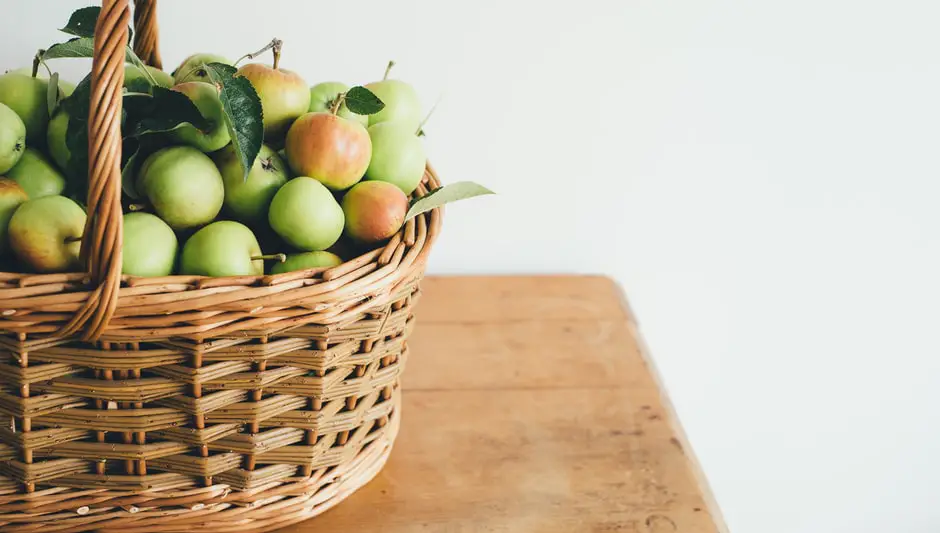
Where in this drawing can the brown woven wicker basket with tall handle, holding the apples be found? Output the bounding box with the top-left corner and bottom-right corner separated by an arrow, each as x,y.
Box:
0,0 -> 441,533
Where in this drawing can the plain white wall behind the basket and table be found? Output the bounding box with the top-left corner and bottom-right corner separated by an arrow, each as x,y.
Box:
0,0 -> 940,533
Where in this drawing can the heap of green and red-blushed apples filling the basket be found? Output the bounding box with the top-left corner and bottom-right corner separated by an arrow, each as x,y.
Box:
0,43 -> 434,277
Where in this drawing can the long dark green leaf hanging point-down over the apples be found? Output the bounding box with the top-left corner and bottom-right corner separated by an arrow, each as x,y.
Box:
204,63 -> 264,180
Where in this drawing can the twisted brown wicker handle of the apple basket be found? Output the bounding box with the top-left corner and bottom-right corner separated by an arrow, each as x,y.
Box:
60,0 -> 160,341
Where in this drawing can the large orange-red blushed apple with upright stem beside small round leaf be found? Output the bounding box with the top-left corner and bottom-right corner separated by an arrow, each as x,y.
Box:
285,113 -> 372,191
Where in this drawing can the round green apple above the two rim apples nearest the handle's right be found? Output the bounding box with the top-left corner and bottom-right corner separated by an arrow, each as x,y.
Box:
137,146 -> 225,230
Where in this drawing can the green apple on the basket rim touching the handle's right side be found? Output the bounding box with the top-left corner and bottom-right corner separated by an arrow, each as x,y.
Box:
121,213 -> 179,277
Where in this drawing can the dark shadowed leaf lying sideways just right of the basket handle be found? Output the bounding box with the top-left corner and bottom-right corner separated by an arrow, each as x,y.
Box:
124,86 -> 210,137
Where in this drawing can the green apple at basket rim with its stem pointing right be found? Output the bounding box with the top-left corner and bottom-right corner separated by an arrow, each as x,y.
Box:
180,220 -> 264,277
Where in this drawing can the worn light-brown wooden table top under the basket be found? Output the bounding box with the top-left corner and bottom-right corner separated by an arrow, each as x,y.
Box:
284,276 -> 726,533
